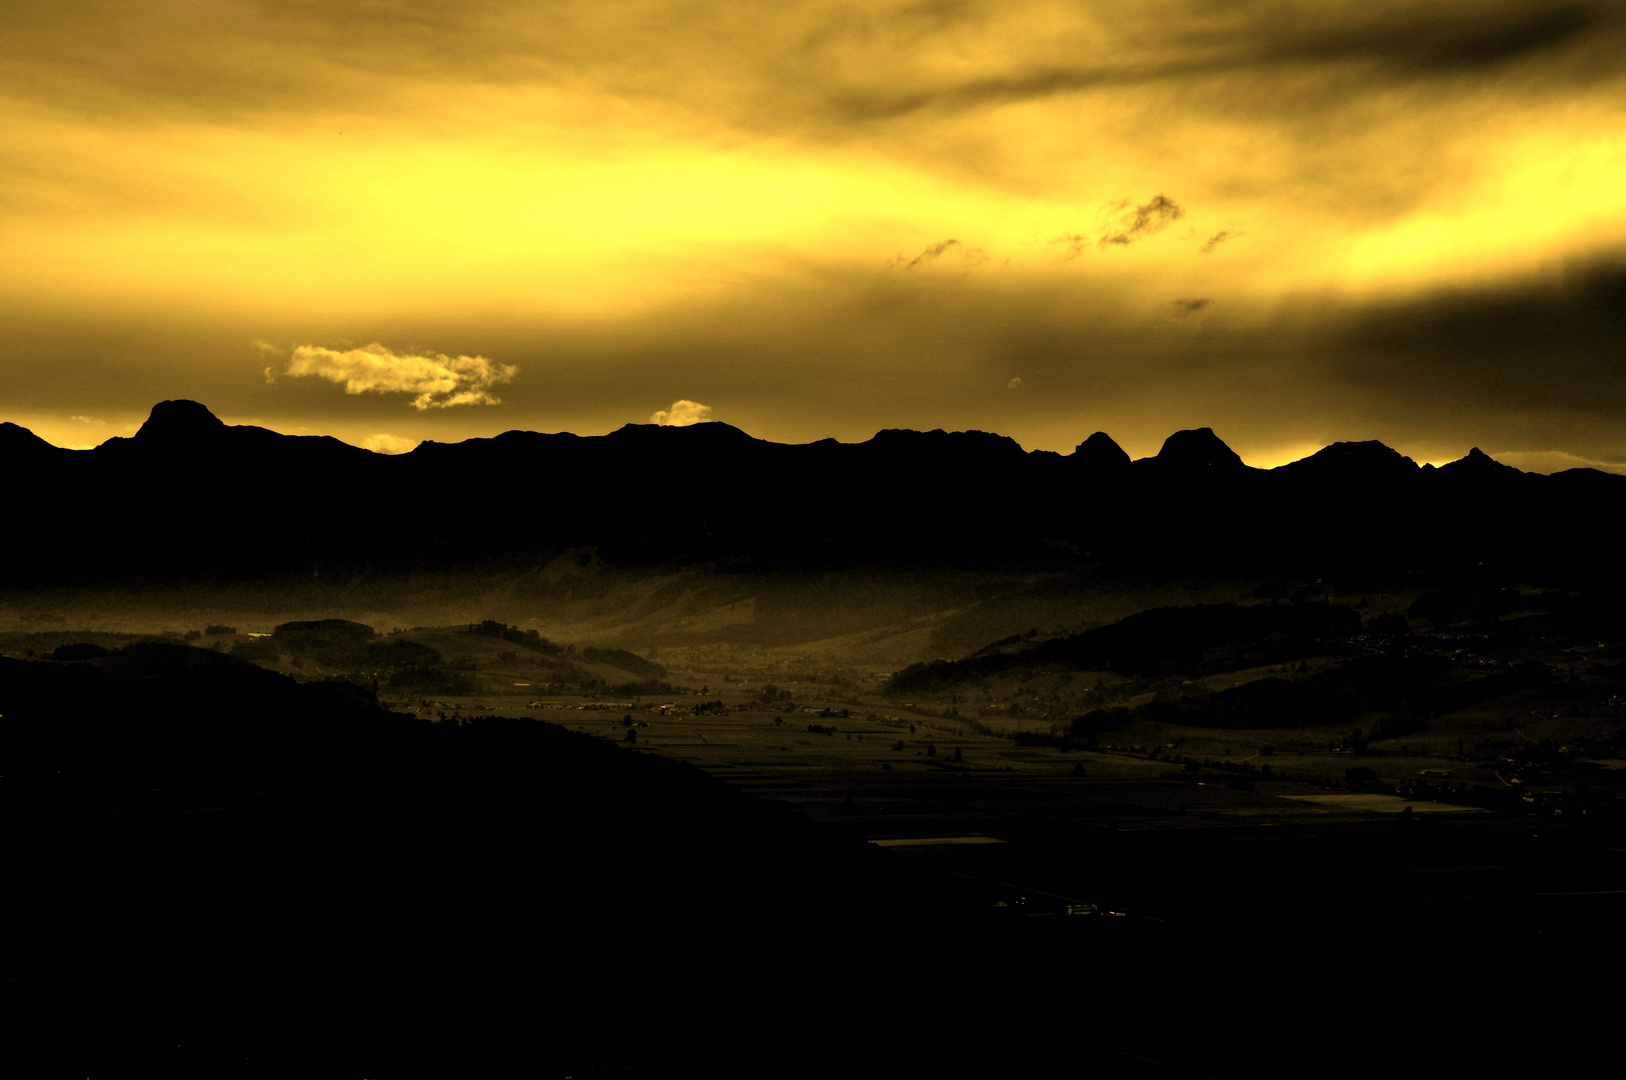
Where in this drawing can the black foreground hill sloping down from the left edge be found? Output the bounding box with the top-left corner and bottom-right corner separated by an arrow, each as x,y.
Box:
0,644 -> 949,1077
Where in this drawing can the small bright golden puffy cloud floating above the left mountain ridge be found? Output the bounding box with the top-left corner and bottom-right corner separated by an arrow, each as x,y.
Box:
281,342 -> 519,410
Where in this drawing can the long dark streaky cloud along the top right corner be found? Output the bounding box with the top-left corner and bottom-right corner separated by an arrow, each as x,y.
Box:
821,0 -> 1621,122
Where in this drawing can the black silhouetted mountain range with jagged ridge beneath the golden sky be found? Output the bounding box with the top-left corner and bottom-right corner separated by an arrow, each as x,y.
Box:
0,400 -> 1626,590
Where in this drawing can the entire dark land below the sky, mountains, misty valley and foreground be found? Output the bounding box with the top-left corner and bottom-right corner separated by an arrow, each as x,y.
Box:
0,400 -> 1626,1078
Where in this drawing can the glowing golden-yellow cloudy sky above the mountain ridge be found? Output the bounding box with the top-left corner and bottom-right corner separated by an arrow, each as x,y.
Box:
0,0 -> 1626,472
